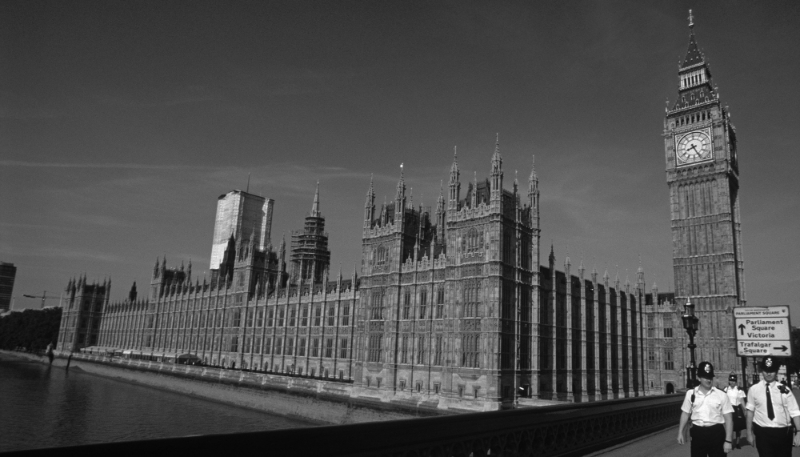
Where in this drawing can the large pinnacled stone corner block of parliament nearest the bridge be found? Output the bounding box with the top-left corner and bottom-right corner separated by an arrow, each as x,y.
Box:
354,137 -> 536,409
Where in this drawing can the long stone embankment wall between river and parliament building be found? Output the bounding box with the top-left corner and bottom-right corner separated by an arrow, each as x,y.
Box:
0,351 -> 458,424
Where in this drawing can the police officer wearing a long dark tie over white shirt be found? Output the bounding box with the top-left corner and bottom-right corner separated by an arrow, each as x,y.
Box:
747,356 -> 800,457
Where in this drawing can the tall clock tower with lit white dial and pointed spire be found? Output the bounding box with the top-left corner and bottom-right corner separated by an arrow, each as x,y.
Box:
664,10 -> 745,373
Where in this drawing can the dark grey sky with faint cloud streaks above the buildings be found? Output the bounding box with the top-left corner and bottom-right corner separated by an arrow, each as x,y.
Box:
0,0 -> 800,318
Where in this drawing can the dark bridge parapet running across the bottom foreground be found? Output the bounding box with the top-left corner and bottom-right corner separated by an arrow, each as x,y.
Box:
9,388 -> 682,457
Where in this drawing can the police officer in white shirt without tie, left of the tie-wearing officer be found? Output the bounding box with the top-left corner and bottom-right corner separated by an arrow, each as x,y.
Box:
678,362 -> 733,457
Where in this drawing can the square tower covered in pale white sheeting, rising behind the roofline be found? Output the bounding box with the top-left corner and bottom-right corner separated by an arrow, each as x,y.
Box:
209,190 -> 275,270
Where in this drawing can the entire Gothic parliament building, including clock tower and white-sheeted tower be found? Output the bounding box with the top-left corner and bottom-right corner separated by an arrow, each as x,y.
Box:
58,14 -> 744,410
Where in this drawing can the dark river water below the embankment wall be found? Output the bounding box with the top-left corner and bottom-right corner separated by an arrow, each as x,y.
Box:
0,356 -> 313,452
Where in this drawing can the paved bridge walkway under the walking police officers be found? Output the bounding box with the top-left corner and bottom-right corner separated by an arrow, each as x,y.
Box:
591,421 -> 800,457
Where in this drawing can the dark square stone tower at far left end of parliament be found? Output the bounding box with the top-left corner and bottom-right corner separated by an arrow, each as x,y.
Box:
56,277 -> 111,352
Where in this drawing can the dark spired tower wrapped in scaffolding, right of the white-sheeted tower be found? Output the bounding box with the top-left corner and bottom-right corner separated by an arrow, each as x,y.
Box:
291,184 -> 331,283
